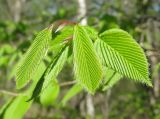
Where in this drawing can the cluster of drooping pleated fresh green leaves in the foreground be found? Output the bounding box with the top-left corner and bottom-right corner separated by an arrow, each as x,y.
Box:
16,25 -> 152,105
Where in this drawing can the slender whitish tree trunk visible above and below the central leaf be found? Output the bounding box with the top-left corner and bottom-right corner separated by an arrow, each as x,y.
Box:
78,0 -> 94,119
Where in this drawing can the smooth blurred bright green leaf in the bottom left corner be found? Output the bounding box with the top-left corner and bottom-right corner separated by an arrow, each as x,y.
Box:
3,95 -> 32,119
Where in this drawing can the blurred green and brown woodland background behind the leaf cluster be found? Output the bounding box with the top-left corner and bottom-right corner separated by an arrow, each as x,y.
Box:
0,0 -> 160,119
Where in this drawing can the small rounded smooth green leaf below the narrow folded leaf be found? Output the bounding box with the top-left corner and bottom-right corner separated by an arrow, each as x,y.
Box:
40,79 -> 60,106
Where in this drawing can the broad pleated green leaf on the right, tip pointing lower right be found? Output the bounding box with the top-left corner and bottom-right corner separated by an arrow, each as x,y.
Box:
95,29 -> 152,86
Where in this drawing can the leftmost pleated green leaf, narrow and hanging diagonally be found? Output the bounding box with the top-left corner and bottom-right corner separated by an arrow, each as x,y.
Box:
16,29 -> 52,88
